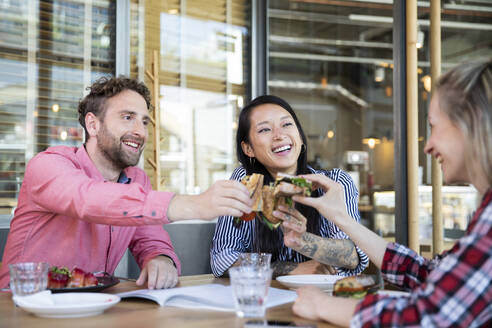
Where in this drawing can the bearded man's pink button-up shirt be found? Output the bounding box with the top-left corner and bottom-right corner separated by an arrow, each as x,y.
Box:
0,146 -> 181,288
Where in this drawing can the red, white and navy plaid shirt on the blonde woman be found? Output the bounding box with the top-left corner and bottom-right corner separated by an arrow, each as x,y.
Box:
351,189 -> 492,328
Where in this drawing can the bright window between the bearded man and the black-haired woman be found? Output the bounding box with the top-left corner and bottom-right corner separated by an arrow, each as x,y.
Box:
131,0 -> 251,194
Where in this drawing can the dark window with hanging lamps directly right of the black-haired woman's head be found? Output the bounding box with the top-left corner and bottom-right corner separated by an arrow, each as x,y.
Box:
268,0 -> 394,238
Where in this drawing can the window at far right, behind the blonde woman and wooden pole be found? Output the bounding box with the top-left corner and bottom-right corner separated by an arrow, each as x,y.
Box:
418,1 -> 492,249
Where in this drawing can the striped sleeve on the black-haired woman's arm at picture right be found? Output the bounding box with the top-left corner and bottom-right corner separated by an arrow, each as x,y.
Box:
315,169 -> 369,276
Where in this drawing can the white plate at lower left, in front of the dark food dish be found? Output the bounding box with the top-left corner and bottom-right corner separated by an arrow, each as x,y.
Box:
13,290 -> 120,318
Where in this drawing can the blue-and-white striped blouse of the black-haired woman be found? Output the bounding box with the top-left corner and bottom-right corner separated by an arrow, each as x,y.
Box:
210,166 -> 369,277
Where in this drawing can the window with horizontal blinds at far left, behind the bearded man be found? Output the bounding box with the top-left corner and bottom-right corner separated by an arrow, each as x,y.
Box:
0,0 -> 115,214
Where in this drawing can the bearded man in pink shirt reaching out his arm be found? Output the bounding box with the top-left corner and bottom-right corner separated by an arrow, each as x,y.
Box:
0,77 -> 252,289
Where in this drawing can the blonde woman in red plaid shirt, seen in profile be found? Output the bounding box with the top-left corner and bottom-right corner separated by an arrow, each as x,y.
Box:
293,60 -> 492,328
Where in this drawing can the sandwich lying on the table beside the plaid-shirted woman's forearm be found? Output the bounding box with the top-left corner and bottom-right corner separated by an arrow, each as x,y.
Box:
333,274 -> 379,298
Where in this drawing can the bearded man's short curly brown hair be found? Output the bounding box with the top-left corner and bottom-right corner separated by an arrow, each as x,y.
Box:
78,76 -> 152,139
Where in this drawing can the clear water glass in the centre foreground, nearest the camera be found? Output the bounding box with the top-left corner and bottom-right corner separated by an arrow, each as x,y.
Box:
229,266 -> 273,318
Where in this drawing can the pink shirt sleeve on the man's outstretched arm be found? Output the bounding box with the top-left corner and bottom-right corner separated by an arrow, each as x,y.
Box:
25,153 -> 174,226
